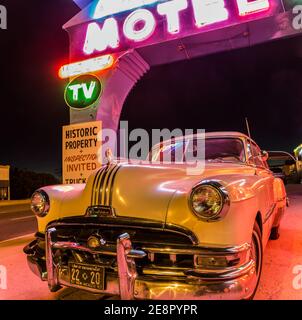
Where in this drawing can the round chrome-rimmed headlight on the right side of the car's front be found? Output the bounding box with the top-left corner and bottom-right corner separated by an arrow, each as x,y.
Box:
190,182 -> 229,221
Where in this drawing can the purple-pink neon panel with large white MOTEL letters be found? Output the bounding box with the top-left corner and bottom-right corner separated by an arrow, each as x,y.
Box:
71,0 -> 282,57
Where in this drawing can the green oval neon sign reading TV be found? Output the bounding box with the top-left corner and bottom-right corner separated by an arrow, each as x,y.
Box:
65,74 -> 102,109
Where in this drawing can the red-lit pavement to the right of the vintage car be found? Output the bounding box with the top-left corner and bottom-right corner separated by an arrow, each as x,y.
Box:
256,185 -> 302,300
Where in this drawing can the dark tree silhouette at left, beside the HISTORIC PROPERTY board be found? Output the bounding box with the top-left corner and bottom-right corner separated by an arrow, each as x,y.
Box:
10,168 -> 60,200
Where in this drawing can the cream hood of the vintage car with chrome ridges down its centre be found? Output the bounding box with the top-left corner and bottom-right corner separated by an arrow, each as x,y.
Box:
92,163 -> 255,222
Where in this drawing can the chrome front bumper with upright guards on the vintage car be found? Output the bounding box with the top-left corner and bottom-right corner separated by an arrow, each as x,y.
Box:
24,228 -> 258,300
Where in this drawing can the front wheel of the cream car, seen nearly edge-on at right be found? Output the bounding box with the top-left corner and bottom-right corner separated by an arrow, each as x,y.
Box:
246,222 -> 263,300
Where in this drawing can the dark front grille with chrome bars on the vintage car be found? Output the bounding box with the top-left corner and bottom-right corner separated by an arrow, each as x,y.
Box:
48,217 -> 194,276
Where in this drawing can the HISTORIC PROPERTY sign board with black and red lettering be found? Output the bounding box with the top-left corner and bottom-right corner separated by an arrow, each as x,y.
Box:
62,121 -> 102,184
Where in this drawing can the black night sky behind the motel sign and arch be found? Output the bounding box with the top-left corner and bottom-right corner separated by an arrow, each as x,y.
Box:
0,0 -> 302,173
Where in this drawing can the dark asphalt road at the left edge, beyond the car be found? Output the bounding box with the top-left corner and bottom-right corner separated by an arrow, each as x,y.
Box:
0,205 -> 37,242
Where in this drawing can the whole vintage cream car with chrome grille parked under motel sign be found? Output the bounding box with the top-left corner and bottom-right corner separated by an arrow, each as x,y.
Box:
24,132 -> 286,299
